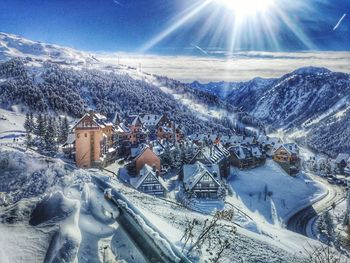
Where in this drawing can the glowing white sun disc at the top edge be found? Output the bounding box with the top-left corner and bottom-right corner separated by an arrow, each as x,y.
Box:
215,0 -> 274,17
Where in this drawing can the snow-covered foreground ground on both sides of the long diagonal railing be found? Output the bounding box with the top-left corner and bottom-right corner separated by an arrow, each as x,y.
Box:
0,147 -> 314,263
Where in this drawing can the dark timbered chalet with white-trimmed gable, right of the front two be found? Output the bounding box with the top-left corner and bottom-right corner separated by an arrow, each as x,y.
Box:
183,162 -> 221,199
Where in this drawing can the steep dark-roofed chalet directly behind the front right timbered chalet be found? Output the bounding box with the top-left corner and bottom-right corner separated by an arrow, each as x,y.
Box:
189,144 -> 230,177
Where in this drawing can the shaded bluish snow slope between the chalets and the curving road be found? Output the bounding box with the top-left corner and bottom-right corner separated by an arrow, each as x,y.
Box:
229,160 -> 326,224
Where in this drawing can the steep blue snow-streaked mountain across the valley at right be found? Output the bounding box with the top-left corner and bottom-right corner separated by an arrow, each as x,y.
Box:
194,67 -> 350,156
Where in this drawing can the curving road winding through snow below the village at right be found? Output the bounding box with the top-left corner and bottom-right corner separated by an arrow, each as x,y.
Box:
287,175 -> 345,238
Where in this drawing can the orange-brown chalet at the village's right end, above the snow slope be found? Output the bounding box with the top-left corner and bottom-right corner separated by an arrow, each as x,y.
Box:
273,143 -> 300,175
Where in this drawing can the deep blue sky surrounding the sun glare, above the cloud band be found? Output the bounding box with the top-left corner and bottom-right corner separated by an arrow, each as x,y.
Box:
0,0 -> 350,55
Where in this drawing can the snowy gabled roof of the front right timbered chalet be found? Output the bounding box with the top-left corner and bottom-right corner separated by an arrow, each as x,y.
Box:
183,162 -> 220,190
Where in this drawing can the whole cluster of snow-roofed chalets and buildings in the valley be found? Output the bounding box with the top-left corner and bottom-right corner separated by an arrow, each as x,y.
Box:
62,111 -> 308,208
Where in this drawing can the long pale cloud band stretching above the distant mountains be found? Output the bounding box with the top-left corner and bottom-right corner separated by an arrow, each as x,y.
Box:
96,52 -> 350,83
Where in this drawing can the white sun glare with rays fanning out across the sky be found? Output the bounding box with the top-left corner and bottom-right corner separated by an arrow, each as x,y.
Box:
139,0 -> 317,57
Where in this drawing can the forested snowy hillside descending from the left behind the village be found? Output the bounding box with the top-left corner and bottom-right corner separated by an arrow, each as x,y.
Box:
0,33 -> 258,134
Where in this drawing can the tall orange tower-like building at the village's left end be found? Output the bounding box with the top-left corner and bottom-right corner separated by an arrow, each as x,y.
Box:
73,111 -> 115,168
